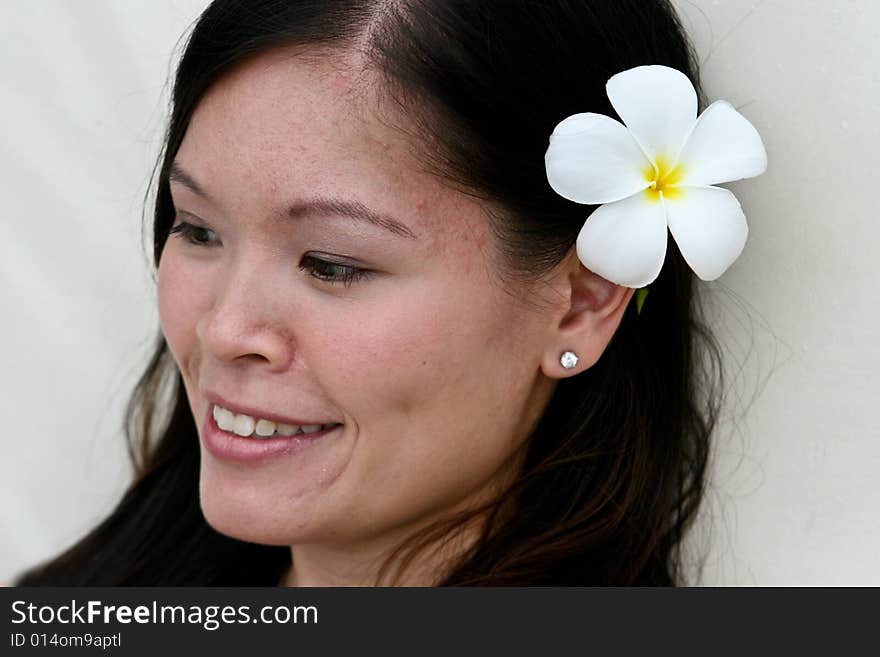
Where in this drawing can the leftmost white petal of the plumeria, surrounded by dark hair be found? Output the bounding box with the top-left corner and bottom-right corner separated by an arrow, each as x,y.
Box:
544,113 -> 651,205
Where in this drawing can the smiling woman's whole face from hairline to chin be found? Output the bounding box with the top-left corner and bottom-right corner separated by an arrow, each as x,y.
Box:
158,51 -> 558,545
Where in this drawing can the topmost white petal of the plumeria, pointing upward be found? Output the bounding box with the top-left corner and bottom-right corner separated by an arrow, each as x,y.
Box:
605,66 -> 698,163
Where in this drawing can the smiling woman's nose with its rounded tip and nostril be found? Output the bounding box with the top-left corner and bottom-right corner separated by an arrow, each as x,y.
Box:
196,269 -> 296,371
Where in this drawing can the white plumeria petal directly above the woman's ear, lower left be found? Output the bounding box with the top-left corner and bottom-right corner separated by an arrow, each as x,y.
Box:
577,193 -> 667,287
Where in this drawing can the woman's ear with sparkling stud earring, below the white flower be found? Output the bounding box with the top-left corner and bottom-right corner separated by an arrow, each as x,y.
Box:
541,253 -> 635,379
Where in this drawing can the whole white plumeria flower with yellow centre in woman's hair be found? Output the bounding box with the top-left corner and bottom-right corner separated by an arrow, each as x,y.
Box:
545,66 -> 767,287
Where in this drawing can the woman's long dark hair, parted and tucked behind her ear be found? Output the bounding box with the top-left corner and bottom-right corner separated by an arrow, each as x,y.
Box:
19,0 -> 720,586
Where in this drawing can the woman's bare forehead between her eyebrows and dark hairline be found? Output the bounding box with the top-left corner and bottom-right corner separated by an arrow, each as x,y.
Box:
177,49 -> 488,243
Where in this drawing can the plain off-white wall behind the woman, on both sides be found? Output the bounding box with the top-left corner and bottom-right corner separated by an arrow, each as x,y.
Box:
0,0 -> 880,585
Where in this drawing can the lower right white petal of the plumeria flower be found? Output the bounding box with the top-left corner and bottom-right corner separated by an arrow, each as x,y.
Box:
665,187 -> 749,281
